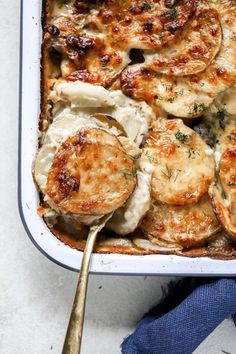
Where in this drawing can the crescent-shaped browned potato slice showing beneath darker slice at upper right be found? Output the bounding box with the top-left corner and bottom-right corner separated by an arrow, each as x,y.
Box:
144,8 -> 222,76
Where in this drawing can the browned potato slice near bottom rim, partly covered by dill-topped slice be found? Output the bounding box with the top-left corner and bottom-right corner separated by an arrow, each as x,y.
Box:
140,195 -> 220,247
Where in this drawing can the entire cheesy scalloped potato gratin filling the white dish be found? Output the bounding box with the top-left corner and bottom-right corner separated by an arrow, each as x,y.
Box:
37,0 -> 236,259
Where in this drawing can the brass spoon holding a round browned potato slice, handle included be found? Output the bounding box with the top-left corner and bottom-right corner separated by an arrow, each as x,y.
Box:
34,119 -> 137,354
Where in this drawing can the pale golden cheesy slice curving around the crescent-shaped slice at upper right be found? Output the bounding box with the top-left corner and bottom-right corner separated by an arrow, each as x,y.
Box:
121,0 -> 236,118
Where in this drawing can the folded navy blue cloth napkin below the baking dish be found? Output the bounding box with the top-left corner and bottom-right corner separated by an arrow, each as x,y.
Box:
121,278 -> 236,354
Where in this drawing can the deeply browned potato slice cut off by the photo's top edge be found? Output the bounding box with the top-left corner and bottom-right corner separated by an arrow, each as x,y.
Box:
93,0 -> 198,50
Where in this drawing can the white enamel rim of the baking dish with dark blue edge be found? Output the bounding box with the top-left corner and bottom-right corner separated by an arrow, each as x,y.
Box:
19,0 -> 236,276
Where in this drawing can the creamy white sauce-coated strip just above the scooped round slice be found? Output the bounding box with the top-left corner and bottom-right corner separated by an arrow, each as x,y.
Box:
50,81 -> 152,146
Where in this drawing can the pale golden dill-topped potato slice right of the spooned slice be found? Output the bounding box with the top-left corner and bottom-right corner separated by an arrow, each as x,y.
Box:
140,119 -> 215,205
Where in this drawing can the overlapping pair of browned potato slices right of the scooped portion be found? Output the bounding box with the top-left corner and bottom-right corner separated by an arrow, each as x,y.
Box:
140,119 -> 220,247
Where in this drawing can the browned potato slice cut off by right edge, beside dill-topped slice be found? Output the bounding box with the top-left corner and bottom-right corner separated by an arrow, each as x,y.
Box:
209,122 -> 236,239
